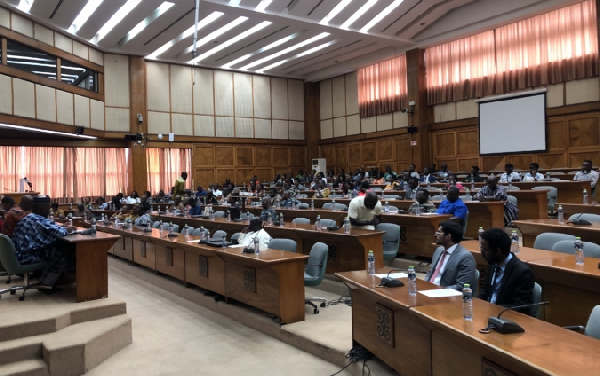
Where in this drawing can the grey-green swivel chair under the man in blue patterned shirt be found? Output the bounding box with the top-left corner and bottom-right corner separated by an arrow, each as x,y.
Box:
0,234 -> 53,301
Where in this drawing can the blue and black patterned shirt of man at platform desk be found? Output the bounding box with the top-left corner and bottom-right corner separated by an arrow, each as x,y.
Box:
11,213 -> 67,264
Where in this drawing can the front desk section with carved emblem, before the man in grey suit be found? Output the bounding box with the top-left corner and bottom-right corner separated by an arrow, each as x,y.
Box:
336,269 -> 462,376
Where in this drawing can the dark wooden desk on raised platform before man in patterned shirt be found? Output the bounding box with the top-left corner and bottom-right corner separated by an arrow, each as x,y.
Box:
58,232 -> 119,303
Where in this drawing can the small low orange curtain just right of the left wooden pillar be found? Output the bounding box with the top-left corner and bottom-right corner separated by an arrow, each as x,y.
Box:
146,148 -> 192,193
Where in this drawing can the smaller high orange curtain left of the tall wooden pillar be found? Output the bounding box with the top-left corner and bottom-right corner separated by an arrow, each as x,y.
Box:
358,55 -> 408,117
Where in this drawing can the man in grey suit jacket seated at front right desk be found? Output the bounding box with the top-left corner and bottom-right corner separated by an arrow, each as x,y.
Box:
425,221 -> 477,291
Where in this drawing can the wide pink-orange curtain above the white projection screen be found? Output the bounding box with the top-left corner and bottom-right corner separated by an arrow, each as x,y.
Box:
425,0 -> 599,105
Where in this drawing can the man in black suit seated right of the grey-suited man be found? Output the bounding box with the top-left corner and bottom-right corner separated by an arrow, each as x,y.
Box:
479,228 -> 534,313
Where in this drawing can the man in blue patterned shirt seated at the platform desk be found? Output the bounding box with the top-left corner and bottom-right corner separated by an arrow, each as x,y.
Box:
11,196 -> 75,286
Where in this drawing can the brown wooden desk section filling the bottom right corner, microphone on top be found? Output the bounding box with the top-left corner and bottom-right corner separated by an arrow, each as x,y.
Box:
412,299 -> 600,376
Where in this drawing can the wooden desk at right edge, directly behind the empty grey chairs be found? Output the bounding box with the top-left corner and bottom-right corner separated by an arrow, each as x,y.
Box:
513,219 -> 600,247
